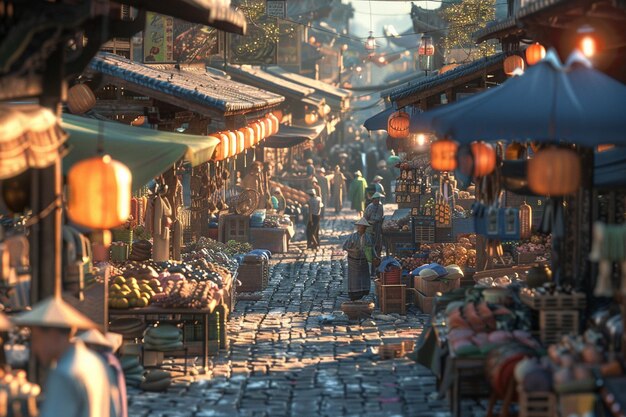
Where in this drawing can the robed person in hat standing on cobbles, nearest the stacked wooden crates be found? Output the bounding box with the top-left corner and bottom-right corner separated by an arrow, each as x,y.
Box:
343,218 -> 376,301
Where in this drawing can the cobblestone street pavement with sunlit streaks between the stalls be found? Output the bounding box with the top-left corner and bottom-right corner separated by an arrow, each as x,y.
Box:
129,216 -> 476,417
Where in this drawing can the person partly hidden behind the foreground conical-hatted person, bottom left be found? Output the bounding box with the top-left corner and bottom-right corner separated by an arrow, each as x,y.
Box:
74,329 -> 128,417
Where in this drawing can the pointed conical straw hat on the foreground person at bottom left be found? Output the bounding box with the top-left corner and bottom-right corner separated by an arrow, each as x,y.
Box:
13,297 -> 97,330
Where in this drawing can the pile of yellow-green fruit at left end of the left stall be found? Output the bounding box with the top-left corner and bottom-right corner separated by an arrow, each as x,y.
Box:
109,275 -> 163,309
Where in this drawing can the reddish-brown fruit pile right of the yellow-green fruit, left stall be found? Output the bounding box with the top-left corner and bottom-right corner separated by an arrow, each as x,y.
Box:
152,279 -> 218,309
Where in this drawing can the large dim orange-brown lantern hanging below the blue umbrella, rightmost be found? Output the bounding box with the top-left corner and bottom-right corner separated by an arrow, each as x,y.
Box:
528,146 -> 581,197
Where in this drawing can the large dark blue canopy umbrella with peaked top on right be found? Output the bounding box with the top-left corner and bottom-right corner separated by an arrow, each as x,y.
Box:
411,51 -> 626,146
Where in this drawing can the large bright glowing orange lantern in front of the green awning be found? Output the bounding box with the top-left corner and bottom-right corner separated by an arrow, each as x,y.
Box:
67,155 -> 132,229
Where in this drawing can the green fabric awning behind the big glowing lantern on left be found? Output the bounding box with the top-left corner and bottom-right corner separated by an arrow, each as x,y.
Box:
62,114 -> 219,189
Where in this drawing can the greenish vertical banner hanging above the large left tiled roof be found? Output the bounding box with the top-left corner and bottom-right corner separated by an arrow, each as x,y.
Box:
143,12 -> 174,62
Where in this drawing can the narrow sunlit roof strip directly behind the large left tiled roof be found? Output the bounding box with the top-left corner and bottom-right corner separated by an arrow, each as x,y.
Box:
224,65 -> 315,99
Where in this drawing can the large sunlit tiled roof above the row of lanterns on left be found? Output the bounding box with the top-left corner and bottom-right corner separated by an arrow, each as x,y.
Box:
90,53 -> 284,114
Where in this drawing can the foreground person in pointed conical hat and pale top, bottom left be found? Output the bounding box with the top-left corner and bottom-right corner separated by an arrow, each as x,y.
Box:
14,297 -> 116,417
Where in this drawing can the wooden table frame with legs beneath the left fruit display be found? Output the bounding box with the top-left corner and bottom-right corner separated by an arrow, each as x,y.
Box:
109,299 -> 228,369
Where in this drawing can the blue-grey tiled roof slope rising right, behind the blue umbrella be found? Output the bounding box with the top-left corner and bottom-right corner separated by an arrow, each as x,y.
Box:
381,52 -> 507,101
